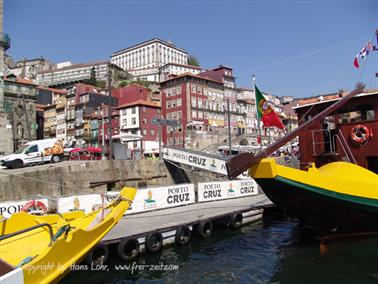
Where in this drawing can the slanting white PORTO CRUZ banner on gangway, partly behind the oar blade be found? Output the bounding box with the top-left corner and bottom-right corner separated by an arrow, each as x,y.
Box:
163,148 -> 250,179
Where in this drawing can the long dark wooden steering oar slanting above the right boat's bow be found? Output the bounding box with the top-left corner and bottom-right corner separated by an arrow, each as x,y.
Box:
226,83 -> 365,179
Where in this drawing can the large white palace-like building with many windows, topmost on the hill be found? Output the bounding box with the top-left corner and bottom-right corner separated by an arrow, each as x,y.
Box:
111,38 -> 188,82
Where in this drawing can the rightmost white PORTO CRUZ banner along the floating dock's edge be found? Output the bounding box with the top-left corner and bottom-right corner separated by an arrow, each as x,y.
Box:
198,179 -> 258,202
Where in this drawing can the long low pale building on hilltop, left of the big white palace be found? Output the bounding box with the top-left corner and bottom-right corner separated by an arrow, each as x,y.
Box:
37,61 -> 124,86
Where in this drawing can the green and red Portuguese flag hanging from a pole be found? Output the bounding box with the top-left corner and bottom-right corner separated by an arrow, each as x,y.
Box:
255,86 -> 285,129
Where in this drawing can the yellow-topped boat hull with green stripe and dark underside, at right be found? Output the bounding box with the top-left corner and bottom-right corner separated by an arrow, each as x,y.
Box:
249,159 -> 378,235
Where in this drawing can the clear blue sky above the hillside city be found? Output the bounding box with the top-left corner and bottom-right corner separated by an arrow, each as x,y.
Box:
4,0 -> 378,97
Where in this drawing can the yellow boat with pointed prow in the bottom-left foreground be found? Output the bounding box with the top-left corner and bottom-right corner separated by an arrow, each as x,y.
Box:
0,188 -> 136,283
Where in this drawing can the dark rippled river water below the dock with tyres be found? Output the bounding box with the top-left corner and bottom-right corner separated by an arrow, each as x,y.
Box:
62,214 -> 378,284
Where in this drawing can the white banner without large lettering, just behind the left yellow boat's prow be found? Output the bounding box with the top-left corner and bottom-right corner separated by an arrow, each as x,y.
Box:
57,194 -> 102,213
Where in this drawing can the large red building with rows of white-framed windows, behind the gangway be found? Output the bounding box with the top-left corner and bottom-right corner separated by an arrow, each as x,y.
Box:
161,73 -> 245,148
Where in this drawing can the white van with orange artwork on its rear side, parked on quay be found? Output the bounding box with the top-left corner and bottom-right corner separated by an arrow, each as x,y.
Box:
1,139 -> 64,169
